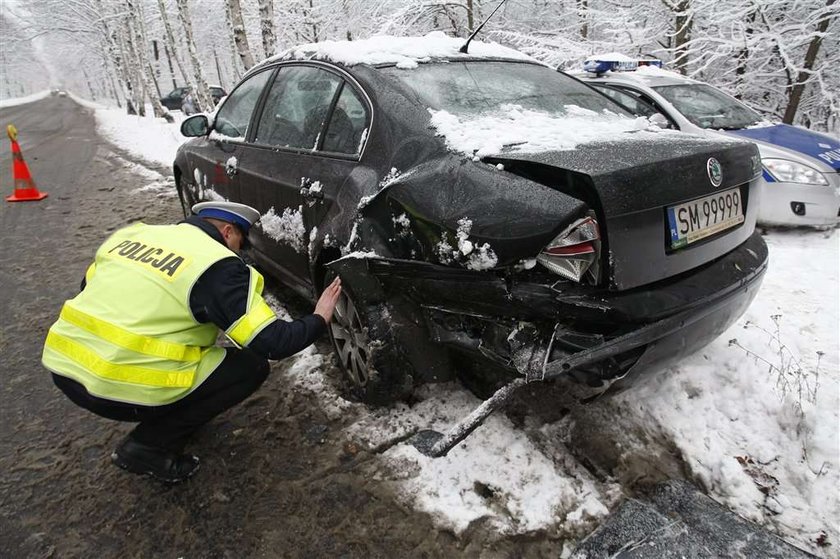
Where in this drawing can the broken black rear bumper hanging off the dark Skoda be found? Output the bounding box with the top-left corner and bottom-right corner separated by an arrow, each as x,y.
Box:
331,233 -> 767,387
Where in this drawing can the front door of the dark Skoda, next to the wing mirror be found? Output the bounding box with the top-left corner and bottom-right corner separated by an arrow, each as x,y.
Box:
185,69 -> 273,206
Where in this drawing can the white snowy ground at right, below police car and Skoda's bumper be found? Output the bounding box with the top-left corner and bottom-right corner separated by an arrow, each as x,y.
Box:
592,230 -> 840,553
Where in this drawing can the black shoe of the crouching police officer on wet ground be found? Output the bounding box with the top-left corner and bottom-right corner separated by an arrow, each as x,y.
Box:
111,436 -> 198,483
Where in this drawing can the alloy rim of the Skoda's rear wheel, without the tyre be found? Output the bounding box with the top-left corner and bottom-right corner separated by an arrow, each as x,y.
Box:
330,292 -> 370,386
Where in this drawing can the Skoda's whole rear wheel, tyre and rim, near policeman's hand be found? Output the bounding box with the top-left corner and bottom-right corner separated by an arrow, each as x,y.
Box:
325,275 -> 414,405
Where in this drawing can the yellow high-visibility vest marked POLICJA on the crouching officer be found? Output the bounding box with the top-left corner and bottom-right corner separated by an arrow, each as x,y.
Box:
42,223 -> 277,406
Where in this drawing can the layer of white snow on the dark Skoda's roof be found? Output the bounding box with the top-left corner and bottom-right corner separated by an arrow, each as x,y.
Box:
253,31 -> 536,69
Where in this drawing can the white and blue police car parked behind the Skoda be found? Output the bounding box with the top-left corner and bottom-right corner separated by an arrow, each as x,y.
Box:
575,53 -> 840,226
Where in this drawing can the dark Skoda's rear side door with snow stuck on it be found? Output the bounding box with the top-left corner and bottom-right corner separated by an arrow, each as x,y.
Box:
239,64 -> 369,293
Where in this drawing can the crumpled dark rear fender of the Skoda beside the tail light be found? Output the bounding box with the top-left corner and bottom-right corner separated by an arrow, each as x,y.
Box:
360,154 -> 587,267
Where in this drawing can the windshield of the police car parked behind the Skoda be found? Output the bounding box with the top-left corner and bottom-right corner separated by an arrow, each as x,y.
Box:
653,84 -> 763,130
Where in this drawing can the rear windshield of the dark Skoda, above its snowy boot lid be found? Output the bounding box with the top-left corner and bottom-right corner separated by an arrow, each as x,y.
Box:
380,61 -> 629,116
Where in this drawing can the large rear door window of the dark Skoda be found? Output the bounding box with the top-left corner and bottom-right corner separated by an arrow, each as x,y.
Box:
255,66 -> 343,150
